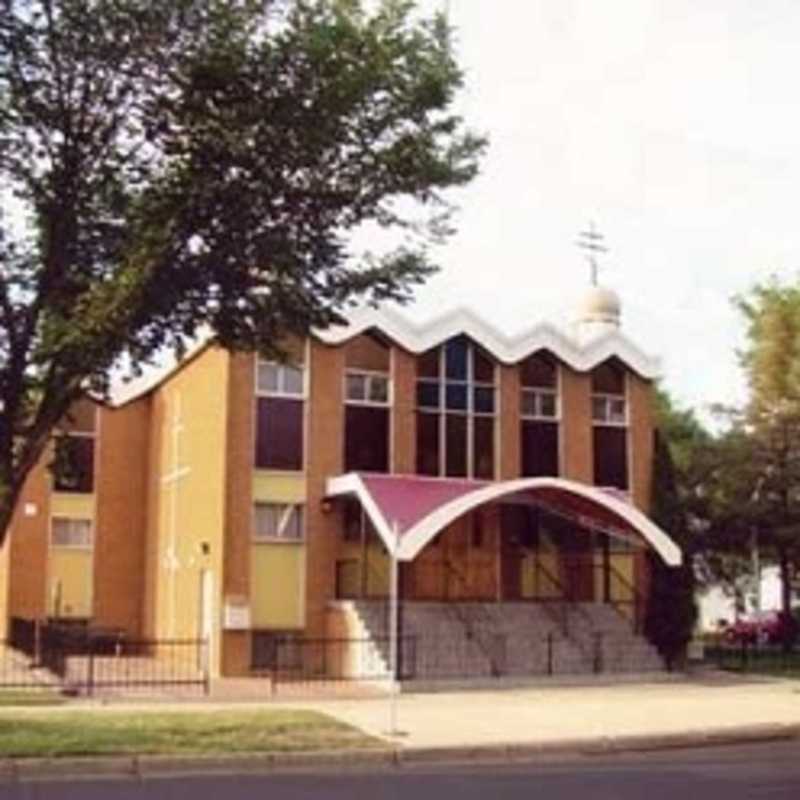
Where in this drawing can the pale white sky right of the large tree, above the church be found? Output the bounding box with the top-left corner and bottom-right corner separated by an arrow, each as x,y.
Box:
384,0 -> 800,417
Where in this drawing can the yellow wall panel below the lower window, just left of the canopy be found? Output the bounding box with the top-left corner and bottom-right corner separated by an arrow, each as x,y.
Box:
250,543 -> 306,629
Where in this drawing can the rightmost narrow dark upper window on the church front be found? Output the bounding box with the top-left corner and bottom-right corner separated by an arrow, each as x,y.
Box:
592,360 -> 629,489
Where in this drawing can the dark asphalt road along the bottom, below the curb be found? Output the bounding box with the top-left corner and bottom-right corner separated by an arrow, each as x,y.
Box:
0,741 -> 800,800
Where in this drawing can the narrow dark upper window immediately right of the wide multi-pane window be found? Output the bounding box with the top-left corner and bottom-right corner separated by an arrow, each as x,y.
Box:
520,352 -> 560,477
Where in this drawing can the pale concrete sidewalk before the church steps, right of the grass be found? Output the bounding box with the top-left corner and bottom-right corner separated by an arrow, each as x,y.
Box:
284,675 -> 800,750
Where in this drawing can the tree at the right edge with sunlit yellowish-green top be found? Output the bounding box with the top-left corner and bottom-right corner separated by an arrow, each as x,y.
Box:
688,280 -> 800,632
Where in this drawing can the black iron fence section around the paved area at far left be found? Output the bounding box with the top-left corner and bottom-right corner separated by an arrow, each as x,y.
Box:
5,619 -> 209,696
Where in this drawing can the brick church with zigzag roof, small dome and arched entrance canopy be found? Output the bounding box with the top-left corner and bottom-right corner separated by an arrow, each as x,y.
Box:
0,287 -> 681,676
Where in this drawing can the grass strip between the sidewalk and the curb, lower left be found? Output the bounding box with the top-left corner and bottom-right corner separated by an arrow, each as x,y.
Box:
0,709 -> 383,757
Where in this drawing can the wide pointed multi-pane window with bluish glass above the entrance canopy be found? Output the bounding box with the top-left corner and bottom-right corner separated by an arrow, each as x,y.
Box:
417,336 -> 496,479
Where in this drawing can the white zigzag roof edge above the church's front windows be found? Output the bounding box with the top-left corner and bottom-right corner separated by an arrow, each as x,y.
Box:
314,308 -> 661,379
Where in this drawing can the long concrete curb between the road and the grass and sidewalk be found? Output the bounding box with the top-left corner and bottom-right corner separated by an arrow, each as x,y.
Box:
0,723 -> 800,784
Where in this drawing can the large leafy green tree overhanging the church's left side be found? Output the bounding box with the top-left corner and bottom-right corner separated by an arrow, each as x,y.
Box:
0,0 -> 484,541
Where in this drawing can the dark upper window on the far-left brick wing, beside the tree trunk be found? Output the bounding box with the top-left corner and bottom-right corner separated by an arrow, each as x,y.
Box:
52,400 -> 97,494
